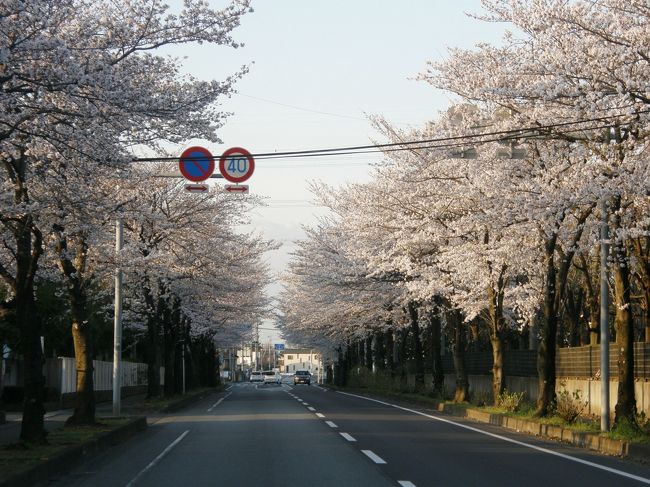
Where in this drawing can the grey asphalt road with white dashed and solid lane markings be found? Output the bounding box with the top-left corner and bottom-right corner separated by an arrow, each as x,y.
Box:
50,384 -> 650,487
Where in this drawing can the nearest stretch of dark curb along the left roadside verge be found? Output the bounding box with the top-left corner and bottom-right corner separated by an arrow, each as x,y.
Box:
0,416 -> 147,487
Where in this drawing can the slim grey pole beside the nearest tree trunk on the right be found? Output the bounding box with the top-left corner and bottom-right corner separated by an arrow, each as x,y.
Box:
599,196 -> 609,431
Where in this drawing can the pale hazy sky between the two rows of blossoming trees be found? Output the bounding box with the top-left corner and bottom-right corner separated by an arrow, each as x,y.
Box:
165,0 -> 505,343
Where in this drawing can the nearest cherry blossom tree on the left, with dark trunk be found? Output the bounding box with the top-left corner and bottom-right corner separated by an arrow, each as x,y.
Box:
0,0 -> 249,443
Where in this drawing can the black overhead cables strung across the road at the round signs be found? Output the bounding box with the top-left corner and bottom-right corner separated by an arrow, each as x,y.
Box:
134,110 -> 650,162
